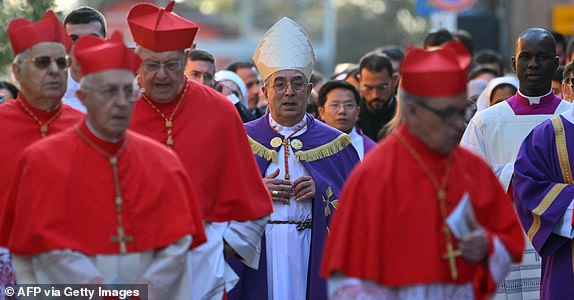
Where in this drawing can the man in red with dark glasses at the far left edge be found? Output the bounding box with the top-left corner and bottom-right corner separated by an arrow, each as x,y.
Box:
0,10 -> 82,284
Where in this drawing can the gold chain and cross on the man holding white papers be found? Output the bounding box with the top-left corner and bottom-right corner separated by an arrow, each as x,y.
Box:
393,131 -> 461,280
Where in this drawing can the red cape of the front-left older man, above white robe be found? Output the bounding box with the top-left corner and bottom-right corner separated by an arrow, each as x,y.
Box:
2,124 -> 205,255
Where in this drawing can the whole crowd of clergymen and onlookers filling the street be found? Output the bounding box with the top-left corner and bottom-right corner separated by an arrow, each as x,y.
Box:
0,1 -> 574,300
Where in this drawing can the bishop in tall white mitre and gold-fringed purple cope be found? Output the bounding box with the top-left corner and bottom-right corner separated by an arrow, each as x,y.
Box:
229,18 -> 359,300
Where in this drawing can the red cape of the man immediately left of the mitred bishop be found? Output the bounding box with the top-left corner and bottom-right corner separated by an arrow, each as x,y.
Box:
130,81 -> 273,222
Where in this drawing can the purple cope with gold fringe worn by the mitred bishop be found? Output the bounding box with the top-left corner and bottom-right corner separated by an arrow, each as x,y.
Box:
228,113 -> 359,300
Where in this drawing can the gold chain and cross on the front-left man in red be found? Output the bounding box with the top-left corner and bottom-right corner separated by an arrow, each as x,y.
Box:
76,127 -> 134,254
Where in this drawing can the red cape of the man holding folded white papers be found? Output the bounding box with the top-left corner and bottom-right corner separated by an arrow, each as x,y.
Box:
321,125 -> 524,299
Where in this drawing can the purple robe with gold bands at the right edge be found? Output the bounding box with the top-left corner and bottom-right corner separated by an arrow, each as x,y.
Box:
512,112 -> 574,299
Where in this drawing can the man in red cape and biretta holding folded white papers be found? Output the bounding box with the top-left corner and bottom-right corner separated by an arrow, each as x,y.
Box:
322,42 -> 524,299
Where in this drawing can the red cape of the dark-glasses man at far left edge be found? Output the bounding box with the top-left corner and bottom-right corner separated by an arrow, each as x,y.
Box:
0,94 -> 84,245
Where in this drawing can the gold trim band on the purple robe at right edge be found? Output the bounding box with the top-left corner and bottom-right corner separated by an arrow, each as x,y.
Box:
528,116 -> 574,241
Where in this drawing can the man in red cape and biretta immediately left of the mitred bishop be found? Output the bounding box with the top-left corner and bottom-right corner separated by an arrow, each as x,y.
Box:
128,1 -> 272,299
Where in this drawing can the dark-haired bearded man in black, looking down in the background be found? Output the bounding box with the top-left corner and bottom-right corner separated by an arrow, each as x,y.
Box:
358,52 -> 398,141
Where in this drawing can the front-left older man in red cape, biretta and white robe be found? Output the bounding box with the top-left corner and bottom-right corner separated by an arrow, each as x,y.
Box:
3,32 -> 205,299
